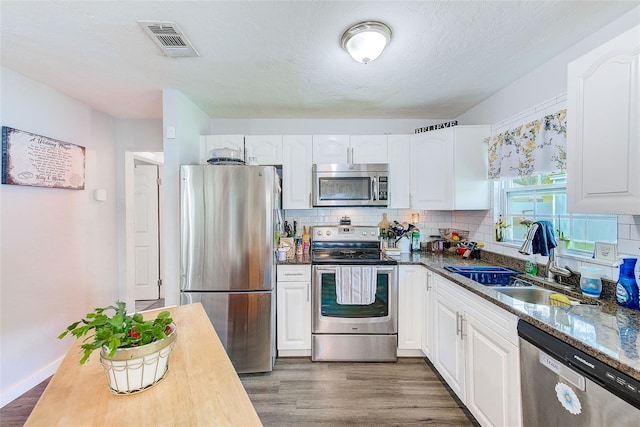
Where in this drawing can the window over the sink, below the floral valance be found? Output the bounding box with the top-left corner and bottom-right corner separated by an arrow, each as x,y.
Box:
500,174 -> 618,255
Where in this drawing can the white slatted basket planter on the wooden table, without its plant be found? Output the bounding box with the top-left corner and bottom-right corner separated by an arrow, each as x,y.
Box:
100,323 -> 178,394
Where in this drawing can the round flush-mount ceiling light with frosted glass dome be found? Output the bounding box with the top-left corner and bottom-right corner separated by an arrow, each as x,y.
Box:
340,21 -> 391,64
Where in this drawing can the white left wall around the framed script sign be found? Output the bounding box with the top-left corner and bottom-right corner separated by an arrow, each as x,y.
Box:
0,68 -> 119,405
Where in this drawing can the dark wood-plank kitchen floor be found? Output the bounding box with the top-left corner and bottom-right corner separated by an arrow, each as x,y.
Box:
0,358 -> 478,427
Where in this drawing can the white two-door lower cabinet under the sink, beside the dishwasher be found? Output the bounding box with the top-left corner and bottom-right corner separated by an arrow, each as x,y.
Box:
431,275 -> 522,427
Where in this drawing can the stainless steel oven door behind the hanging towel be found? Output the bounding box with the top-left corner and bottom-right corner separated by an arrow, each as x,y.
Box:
312,265 -> 398,334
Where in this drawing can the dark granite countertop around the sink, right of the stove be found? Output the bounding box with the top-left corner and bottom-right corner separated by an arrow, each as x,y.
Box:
394,253 -> 640,380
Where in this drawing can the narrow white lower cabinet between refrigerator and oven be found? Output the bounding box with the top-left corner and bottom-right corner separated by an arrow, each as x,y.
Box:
276,265 -> 311,357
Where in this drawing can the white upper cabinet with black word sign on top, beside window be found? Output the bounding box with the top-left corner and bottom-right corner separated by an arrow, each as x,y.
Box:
409,126 -> 490,210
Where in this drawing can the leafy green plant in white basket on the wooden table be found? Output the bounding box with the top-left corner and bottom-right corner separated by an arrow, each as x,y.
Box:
58,301 -> 177,394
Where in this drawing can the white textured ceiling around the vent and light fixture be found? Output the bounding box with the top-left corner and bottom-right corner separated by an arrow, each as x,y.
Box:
0,0 -> 638,119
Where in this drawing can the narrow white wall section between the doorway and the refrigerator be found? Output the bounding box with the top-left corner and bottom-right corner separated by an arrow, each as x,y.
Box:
162,90 -> 209,305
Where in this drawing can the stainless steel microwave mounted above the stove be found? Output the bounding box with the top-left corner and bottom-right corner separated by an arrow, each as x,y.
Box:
313,163 -> 389,207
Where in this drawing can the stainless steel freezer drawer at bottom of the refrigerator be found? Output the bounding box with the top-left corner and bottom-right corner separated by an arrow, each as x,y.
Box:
181,291 -> 275,373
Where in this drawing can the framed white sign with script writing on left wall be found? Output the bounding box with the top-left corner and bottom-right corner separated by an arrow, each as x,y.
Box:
2,126 -> 85,190
